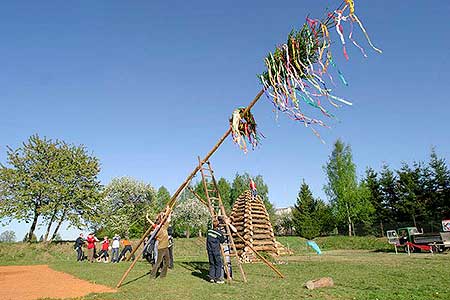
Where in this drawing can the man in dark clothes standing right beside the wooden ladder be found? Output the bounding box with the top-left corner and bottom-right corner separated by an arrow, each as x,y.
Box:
206,220 -> 225,283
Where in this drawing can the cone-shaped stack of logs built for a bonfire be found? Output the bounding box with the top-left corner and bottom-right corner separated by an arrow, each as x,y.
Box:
231,191 -> 280,262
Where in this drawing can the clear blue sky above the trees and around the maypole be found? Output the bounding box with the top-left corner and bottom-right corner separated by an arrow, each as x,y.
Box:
0,0 -> 450,237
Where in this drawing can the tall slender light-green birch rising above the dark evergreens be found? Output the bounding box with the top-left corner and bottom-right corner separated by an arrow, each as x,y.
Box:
324,140 -> 373,236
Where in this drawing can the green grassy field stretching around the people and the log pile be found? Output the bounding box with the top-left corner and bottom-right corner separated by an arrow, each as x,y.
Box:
0,237 -> 450,300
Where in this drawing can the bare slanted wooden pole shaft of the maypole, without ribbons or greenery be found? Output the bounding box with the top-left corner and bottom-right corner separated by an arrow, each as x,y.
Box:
116,90 -> 264,288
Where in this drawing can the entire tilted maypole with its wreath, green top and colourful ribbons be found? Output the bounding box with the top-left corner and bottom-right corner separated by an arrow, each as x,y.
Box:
117,0 -> 382,287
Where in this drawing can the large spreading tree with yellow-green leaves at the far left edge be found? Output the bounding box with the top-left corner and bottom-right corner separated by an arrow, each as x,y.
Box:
0,135 -> 100,241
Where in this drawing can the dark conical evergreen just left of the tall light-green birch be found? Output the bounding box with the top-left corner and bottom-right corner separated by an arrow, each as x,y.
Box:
292,181 -> 320,240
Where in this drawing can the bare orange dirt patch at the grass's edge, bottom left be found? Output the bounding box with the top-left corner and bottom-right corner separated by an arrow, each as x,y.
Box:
0,265 -> 115,300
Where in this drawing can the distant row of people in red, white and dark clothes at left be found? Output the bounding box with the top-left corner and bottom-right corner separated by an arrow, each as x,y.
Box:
74,233 -> 134,263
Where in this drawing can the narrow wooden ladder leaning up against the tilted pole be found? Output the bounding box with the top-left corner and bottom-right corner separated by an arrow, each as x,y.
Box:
196,157 -> 247,283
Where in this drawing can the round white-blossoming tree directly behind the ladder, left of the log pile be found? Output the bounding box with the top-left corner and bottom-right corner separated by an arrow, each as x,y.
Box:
172,198 -> 210,238
